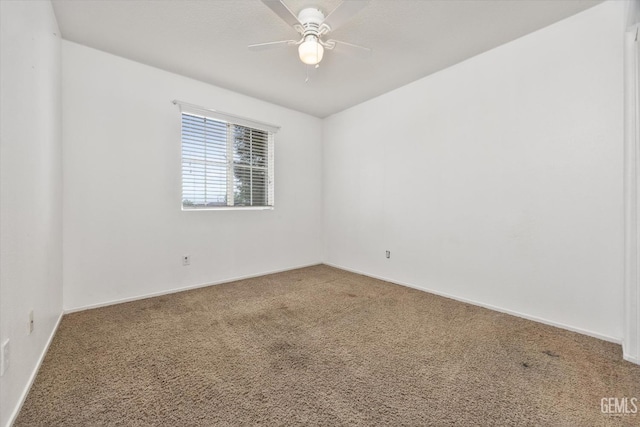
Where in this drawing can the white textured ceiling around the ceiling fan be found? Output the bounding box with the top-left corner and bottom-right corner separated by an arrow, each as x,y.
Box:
53,0 -> 600,117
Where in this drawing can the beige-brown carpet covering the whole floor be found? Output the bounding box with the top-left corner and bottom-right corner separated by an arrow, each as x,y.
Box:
16,266 -> 640,426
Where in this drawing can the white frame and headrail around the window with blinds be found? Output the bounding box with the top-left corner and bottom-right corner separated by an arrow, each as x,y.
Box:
172,100 -> 280,212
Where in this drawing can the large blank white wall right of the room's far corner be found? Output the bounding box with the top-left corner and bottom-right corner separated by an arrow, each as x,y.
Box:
323,2 -> 626,340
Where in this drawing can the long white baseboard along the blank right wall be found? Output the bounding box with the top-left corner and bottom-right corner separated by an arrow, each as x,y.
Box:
325,262 -> 622,344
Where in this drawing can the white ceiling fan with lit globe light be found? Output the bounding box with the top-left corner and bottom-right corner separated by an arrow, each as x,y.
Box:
249,0 -> 371,67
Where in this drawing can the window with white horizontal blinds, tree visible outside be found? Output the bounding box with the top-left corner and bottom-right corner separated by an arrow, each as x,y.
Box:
181,104 -> 277,210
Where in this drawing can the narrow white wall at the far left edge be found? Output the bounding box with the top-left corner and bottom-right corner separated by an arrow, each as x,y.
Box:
0,1 -> 62,426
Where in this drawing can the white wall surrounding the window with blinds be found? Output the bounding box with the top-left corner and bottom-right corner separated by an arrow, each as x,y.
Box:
62,41 -> 322,310
